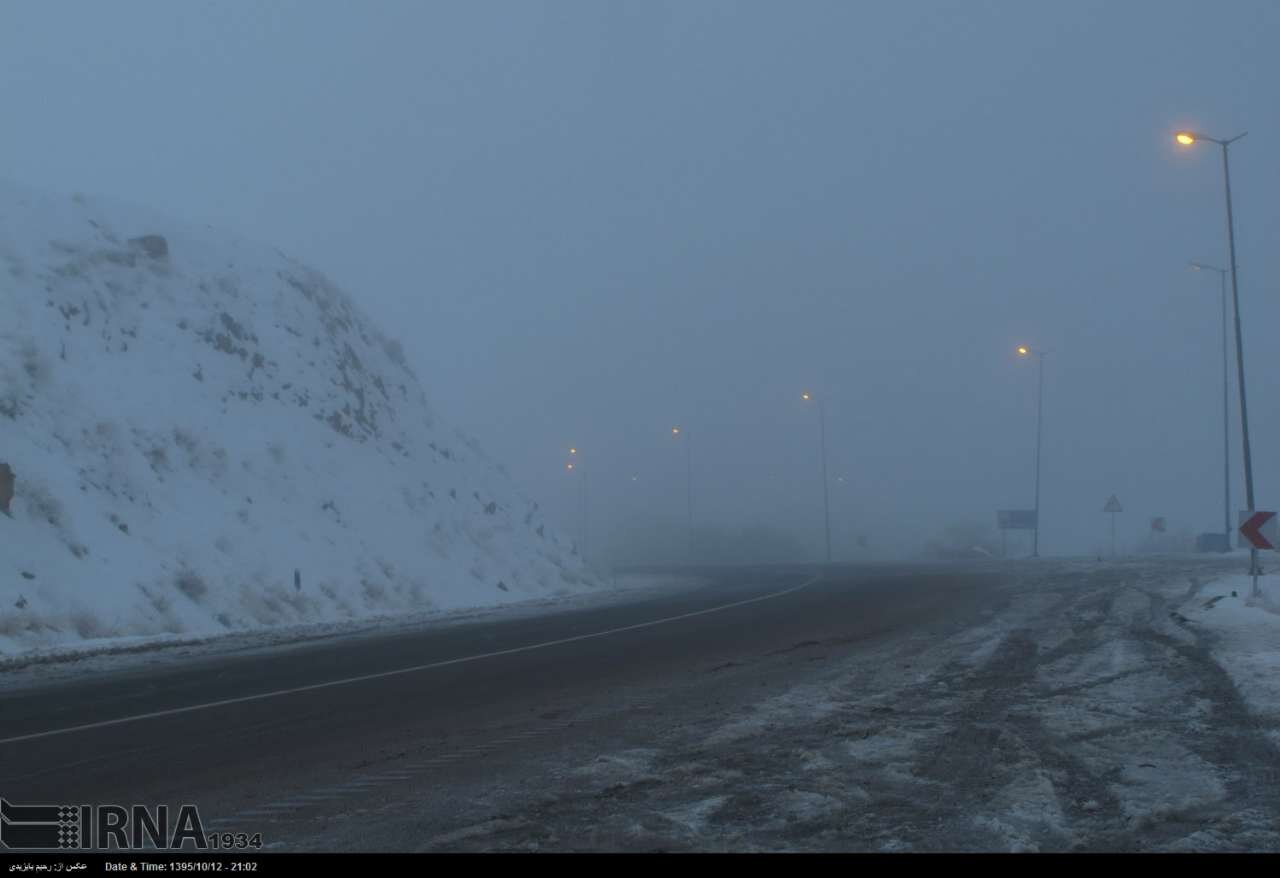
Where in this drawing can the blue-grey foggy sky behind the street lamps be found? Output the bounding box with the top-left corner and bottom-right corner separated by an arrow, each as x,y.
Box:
0,0 -> 1280,555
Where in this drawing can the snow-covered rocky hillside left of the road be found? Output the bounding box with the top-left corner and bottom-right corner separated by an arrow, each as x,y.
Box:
0,182 -> 593,653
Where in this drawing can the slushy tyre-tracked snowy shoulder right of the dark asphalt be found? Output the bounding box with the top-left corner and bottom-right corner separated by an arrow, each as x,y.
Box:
376,559 -> 1280,851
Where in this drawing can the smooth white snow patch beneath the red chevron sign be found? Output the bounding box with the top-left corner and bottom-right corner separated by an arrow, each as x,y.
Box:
1181,575 -> 1280,746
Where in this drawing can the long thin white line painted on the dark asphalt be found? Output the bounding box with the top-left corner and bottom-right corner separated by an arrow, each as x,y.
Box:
0,575 -> 822,745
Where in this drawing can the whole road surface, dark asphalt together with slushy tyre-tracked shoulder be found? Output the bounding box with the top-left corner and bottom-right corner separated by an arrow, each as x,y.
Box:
0,563 -> 1259,851
